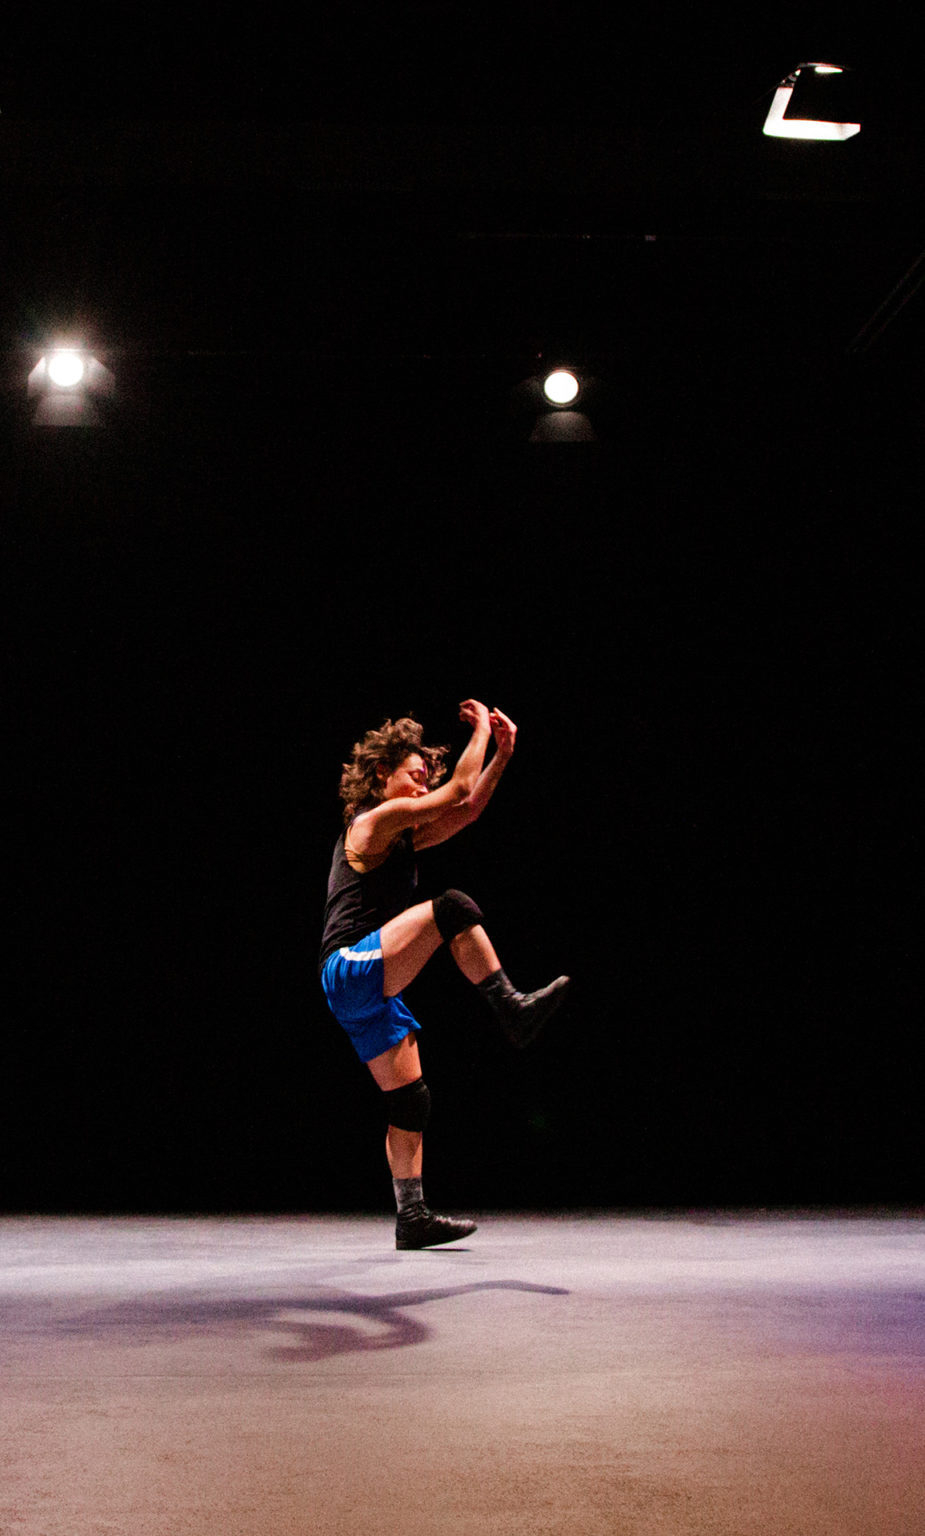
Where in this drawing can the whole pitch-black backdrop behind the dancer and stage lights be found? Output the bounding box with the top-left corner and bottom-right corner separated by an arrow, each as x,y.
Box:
0,12 -> 923,1210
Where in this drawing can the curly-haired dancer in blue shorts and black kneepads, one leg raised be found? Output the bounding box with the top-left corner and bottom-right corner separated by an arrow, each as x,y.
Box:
320,699 -> 569,1249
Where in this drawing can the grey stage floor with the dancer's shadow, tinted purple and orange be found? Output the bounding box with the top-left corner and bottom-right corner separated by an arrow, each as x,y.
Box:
0,1213 -> 925,1536
